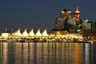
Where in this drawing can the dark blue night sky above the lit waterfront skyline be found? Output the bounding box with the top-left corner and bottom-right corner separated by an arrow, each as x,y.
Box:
0,0 -> 96,29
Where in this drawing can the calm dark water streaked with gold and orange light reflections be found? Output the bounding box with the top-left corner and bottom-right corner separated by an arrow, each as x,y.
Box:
0,42 -> 90,64
